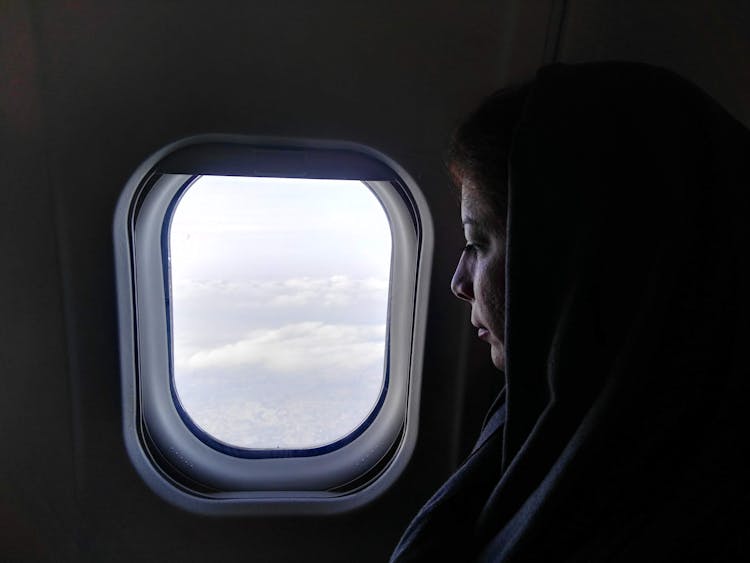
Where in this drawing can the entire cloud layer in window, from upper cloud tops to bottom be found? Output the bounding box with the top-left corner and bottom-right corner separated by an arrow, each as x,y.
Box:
172,275 -> 388,449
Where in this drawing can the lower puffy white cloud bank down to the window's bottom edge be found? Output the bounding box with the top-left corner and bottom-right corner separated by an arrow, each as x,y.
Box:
175,322 -> 386,449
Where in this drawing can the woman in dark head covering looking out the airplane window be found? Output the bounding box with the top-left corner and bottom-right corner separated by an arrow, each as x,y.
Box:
392,63 -> 750,562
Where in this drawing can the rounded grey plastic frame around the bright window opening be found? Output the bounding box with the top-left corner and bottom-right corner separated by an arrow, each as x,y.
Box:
113,135 -> 433,514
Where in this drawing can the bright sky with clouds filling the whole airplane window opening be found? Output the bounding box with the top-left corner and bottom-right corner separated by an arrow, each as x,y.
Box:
169,176 -> 391,449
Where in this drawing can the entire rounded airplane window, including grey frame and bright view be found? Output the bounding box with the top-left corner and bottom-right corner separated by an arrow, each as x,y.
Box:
113,135 -> 434,514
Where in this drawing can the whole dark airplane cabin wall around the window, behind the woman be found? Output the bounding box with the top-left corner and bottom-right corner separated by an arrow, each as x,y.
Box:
0,0 -> 750,561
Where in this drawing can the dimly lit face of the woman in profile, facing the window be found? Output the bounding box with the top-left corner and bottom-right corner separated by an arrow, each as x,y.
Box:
451,180 -> 505,369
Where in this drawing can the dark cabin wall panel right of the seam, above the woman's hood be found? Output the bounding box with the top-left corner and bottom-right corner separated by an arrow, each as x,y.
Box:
559,0 -> 750,127
